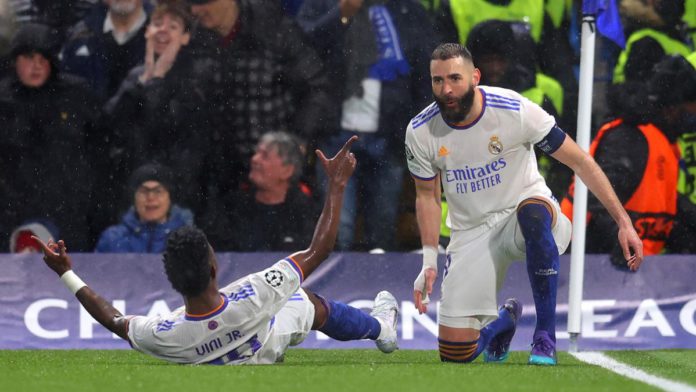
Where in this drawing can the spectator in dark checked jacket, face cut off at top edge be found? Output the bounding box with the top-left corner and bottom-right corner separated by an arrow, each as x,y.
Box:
189,0 -> 336,201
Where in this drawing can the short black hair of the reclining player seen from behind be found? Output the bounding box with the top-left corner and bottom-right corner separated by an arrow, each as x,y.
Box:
162,226 -> 212,297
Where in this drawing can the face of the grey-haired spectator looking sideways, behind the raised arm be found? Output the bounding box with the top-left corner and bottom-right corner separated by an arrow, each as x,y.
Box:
249,143 -> 294,189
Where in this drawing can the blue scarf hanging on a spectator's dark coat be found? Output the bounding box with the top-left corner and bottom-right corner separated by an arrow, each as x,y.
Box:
368,5 -> 411,81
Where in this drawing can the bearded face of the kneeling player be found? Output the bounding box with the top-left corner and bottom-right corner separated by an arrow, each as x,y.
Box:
430,57 -> 480,123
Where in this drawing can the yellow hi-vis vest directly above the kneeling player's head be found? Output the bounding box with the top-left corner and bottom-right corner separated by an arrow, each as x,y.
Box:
450,0 -> 544,45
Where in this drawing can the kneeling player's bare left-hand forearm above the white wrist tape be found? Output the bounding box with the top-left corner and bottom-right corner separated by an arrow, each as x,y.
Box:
414,176 -> 442,248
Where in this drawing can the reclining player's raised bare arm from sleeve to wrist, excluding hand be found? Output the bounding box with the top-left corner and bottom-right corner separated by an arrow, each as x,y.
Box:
292,184 -> 345,277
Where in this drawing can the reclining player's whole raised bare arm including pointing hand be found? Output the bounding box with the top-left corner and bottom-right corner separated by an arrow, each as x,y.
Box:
291,136 -> 358,277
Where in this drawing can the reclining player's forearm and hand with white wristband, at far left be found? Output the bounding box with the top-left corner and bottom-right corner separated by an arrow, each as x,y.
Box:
32,237 -> 128,340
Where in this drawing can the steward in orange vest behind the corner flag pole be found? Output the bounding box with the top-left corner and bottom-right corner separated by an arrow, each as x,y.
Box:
561,119 -> 679,256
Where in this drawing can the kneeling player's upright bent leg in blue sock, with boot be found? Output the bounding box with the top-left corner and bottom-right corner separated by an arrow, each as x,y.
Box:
517,198 -> 559,365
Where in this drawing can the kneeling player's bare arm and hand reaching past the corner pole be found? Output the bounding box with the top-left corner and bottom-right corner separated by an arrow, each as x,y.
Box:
551,136 -> 643,271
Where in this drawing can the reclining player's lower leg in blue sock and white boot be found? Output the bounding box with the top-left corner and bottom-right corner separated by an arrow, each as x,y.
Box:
305,290 -> 399,353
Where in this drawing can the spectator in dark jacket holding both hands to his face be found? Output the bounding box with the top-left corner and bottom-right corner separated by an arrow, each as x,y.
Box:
103,1 -> 212,217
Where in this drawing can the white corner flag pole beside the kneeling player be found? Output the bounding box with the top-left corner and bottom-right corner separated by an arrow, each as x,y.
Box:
568,0 -> 597,352
